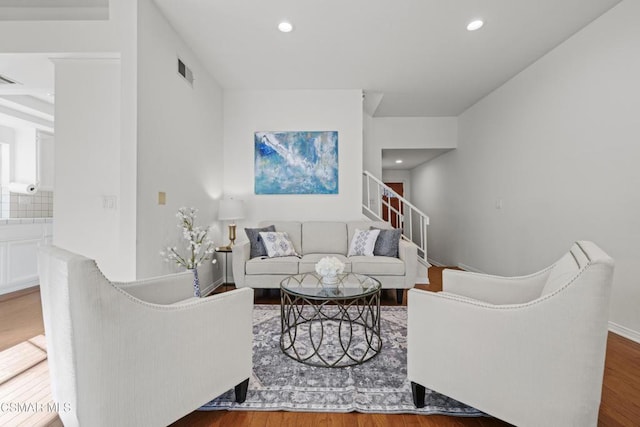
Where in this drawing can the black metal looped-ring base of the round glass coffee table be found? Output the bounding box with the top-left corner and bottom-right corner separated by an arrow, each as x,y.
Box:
280,291 -> 382,368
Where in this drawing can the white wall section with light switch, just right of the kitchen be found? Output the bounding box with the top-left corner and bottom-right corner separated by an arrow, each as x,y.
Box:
53,59 -> 126,280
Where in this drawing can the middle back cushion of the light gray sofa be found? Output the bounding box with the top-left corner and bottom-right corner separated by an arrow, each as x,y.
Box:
302,221 -> 347,255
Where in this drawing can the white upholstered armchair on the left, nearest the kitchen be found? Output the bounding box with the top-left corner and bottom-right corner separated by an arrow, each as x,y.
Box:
38,247 -> 253,427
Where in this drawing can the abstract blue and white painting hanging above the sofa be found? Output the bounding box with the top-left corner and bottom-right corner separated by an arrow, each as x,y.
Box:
254,131 -> 338,194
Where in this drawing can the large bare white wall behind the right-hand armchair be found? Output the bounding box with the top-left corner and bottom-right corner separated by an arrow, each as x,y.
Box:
413,0 -> 640,339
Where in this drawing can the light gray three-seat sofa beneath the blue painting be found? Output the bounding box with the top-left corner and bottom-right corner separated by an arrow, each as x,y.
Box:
233,221 -> 418,303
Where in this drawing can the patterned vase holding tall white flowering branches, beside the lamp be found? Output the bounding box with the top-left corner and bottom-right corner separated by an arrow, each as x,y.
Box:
160,208 -> 216,298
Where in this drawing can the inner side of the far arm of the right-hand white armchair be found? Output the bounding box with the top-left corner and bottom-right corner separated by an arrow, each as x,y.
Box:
442,267 -> 551,304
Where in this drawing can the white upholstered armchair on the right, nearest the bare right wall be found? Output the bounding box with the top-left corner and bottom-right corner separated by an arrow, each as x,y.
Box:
407,241 -> 613,427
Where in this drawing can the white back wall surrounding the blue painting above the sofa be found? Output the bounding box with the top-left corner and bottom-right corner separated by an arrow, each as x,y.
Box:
224,90 -> 363,227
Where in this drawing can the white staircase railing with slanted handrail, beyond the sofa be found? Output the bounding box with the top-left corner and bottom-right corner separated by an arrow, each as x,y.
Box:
362,171 -> 431,284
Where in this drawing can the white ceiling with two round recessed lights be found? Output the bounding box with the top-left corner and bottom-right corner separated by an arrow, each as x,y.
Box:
155,0 -> 619,116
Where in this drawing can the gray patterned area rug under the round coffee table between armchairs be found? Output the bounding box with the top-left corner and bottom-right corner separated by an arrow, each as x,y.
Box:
200,305 -> 484,417
